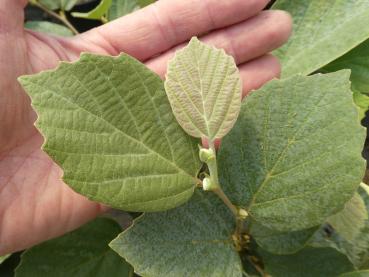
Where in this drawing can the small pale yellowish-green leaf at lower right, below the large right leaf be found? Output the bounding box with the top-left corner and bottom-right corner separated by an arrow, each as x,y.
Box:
327,193 -> 368,241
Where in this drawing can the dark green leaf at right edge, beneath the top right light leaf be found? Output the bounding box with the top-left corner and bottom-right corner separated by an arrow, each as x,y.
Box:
320,40 -> 369,93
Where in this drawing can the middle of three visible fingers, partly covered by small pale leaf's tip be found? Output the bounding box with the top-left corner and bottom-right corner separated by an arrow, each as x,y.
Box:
146,11 -> 292,76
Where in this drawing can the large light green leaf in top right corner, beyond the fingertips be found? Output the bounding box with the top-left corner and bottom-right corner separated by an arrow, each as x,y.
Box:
273,0 -> 369,77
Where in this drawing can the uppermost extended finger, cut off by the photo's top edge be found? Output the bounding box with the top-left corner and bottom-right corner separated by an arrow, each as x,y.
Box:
74,0 -> 269,60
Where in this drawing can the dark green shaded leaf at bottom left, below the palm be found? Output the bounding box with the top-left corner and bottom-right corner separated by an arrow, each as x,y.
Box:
16,218 -> 133,277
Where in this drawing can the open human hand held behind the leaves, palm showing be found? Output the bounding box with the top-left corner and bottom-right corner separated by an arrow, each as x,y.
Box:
0,0 -> 291,255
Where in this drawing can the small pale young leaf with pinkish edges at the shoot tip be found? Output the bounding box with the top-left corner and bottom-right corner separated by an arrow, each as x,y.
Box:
165,38 -> 241,140
